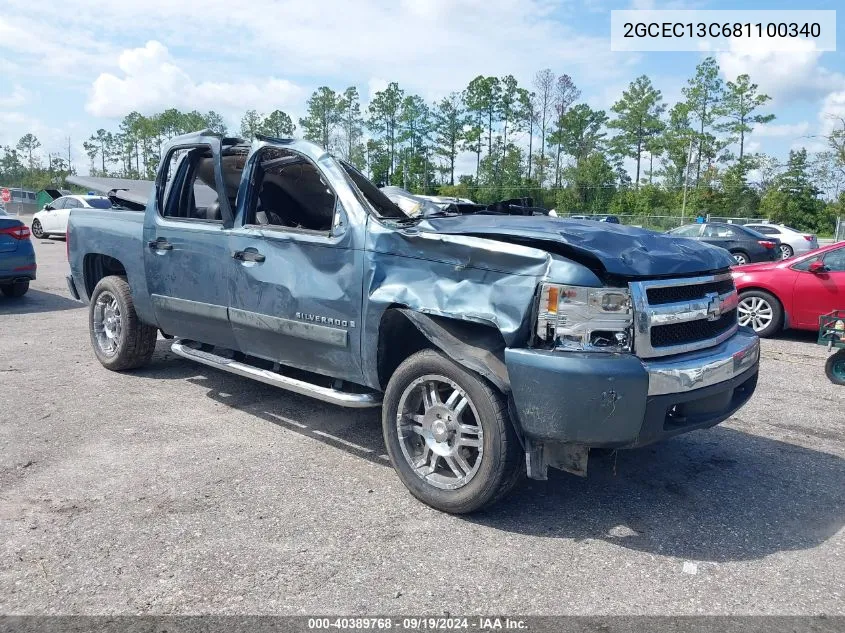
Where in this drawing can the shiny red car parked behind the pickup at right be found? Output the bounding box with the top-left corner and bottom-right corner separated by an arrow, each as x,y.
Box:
733,242 -> 845,337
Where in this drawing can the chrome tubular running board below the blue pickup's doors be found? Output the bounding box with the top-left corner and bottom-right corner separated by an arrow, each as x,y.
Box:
170,340 -> 381,409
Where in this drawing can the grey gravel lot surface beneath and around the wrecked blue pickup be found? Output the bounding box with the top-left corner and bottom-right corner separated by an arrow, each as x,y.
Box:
0,240 -> 845,614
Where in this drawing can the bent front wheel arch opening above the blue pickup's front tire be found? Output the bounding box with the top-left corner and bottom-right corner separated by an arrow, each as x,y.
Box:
377,305 -> 510,395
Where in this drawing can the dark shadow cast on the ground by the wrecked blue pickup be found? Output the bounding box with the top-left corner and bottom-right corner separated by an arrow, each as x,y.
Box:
150,350 -> 845,562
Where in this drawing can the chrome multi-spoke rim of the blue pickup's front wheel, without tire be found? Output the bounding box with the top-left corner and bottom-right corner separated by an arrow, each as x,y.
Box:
396,374 -> 484,490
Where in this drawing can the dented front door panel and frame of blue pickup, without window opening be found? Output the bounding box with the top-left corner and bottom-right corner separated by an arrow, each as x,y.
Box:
229,146 -> 363,382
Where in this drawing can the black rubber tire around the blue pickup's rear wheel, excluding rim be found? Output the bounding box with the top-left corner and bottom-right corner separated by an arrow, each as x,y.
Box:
88,275 -> 158,371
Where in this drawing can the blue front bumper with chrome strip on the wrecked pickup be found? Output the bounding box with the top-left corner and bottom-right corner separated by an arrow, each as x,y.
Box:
505,328 -> 760,448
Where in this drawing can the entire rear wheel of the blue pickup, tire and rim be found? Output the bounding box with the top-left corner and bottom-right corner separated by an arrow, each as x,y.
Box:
88,275 -> 158,371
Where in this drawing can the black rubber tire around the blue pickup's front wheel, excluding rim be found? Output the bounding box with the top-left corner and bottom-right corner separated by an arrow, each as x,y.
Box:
382,349 -> 525,514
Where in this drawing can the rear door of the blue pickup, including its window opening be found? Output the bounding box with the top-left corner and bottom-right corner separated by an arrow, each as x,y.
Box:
144,136 -> 235,348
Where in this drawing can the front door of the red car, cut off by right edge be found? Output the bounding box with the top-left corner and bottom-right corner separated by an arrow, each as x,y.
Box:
793,246 -> 845,329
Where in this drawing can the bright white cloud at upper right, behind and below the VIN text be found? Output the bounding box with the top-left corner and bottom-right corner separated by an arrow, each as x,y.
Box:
716,38 -> 845,105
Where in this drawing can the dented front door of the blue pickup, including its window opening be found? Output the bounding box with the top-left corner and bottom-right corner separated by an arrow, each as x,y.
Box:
229,145 -> 364,382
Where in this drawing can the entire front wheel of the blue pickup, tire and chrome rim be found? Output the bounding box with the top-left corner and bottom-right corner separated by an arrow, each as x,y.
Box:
382,350 -> 523,514
